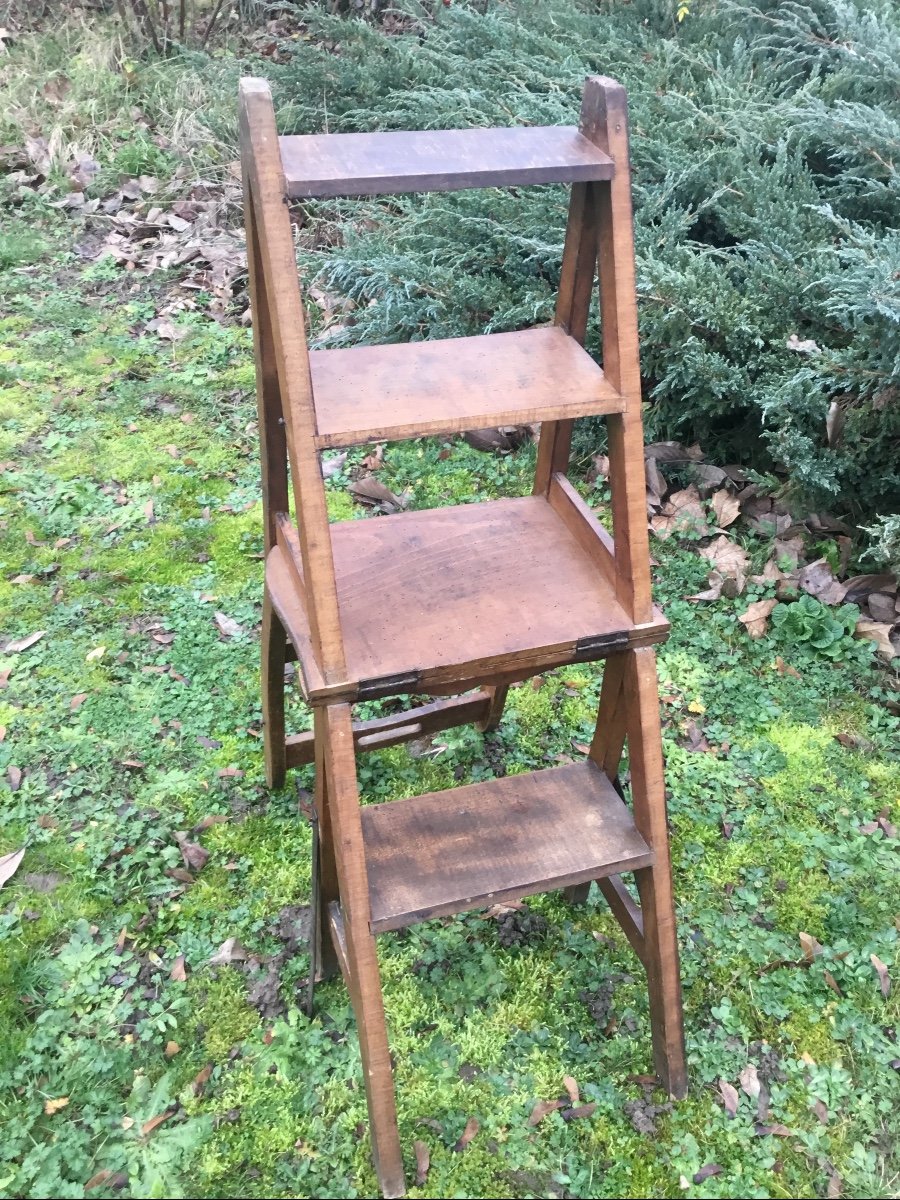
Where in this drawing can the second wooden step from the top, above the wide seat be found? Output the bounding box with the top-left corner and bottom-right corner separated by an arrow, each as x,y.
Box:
310,325 -> 625,450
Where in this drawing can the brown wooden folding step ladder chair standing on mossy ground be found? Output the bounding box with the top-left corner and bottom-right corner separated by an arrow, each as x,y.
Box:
240,77 -> 686,1196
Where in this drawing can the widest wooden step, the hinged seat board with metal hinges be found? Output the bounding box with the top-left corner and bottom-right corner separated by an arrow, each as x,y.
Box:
265,496 -> 668,702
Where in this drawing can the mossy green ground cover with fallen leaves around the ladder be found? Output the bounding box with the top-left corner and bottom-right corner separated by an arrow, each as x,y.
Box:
0,2 -> 900,1196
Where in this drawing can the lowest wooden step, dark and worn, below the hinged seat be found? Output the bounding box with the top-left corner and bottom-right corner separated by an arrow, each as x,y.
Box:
362,760 -> 653,932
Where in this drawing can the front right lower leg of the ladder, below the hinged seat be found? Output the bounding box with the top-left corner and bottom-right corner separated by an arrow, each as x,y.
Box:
623,647 -> 688,1099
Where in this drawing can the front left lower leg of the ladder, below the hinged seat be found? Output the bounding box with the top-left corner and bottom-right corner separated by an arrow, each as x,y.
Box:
317,704 -> 406,1196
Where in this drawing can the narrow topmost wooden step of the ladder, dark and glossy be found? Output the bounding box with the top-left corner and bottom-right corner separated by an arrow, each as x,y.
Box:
278,125 -> 614,199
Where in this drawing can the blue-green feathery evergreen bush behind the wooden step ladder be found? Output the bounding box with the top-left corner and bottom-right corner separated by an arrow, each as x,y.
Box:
259,0 -> 900,554
